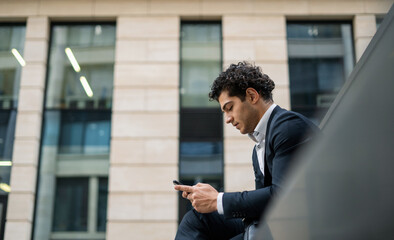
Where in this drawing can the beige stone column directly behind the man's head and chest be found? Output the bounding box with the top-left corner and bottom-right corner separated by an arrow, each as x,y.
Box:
223,15 -> 290,191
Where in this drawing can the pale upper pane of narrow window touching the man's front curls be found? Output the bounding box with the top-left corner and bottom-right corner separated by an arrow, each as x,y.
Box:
181,23 -> 222,107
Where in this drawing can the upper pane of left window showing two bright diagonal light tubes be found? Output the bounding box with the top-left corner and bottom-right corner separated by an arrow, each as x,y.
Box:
46,24 -> 115,109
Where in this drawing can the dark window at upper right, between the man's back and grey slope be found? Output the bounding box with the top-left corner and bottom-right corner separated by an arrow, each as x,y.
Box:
287,22 -> 354,123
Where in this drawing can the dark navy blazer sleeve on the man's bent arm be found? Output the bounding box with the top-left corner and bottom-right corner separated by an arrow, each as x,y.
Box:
223,114 -> 310,219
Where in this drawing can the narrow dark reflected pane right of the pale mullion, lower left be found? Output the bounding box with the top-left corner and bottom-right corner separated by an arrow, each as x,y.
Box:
97,178 -> 108,232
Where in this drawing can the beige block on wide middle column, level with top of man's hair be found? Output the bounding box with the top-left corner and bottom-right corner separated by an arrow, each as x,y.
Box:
114,63 -> 179,88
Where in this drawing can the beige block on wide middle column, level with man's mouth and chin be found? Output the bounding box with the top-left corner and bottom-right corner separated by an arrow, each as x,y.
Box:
112,112 -> 178,137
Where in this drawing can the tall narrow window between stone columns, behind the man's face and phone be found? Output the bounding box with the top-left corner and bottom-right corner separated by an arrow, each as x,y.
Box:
179,22 -> 223,221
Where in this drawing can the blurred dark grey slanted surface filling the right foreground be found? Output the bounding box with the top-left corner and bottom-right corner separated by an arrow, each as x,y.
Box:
257,7 -> 394,240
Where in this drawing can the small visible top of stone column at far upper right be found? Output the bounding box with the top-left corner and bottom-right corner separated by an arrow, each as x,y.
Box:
353,14 -> 376,61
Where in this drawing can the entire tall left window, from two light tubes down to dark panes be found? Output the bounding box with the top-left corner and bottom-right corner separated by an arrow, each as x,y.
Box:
33,23 -> 115,240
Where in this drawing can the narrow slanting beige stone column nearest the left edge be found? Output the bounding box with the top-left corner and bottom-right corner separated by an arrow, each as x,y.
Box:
5,17 -> 49,240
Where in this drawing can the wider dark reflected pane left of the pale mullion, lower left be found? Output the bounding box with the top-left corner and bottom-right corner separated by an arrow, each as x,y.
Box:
52,178 -> 89,232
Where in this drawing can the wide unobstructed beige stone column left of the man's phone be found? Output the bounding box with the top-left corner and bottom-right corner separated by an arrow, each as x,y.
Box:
107,16 -> 180,240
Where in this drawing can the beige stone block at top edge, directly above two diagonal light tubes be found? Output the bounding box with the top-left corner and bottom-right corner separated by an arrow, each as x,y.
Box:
39,0 -> 95,17
